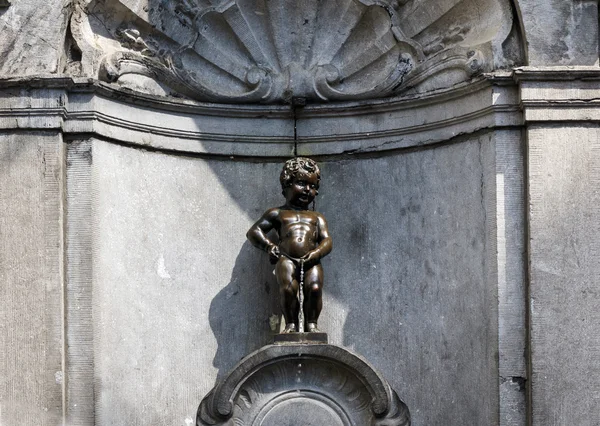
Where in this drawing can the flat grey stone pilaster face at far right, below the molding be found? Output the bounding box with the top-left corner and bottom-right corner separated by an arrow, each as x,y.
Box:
528,123 -> 600,426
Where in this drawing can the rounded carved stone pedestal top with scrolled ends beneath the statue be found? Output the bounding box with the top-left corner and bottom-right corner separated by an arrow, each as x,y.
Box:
196,344 -> 410,426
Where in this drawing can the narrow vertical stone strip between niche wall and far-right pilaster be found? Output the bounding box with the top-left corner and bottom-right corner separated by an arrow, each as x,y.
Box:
494,130 -> 527,426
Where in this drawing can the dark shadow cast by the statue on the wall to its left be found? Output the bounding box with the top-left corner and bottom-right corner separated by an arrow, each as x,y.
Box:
209,241 -> 279,378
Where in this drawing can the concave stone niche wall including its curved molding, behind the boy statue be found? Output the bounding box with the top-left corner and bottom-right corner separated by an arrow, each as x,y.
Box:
3,71 -> 523,425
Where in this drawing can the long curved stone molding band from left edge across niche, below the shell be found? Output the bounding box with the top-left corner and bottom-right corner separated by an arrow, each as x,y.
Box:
0,75 -> 522,157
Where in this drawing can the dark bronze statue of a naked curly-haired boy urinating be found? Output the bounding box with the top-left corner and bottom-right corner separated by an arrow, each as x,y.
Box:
246,157 -> 332,333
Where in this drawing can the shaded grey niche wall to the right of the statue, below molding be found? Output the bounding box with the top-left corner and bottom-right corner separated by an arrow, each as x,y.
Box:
320,135 -> 498,425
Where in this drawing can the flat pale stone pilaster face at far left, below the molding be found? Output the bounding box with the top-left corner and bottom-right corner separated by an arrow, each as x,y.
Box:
0,132 -> 64,426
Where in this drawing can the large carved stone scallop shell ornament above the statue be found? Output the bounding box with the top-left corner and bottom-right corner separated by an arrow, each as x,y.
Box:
71,0 -> 512,103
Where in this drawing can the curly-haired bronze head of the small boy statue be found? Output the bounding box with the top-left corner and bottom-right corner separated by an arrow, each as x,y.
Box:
279,157 -> 321,207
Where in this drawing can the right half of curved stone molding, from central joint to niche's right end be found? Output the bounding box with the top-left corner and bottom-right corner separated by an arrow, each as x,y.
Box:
296,80 -> 522,156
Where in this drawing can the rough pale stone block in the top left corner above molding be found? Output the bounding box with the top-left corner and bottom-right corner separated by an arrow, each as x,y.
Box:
0,0 -> 70,76
